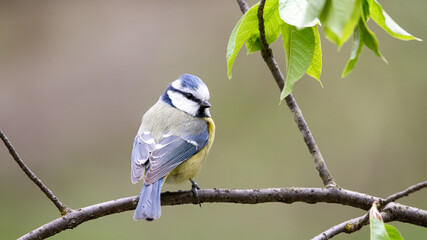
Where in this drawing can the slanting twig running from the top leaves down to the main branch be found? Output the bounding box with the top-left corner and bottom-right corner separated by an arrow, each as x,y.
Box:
252,0 -> 337,187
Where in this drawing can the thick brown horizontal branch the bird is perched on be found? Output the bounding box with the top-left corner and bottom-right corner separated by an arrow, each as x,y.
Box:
20,188 -> 427,239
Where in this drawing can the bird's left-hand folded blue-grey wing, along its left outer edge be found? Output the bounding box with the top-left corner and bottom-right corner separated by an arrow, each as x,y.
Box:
131,132 -> 156,184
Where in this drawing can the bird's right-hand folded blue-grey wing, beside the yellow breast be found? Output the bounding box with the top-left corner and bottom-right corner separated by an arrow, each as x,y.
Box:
144,126 -> 209,184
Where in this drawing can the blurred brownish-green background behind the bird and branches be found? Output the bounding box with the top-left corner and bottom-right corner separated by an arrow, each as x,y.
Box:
0,0 -> 427,239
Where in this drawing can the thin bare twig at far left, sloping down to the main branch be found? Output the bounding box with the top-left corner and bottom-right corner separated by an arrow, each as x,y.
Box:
0,130 -> 69,215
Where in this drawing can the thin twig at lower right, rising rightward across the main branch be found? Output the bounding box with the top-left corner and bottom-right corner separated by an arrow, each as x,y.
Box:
312,181 -> 427,240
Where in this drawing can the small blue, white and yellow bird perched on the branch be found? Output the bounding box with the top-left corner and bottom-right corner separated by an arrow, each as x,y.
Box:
131,74 -> 215,221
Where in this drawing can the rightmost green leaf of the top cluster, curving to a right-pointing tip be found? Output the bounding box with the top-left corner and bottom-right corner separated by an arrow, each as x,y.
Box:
367,0 -> 422,41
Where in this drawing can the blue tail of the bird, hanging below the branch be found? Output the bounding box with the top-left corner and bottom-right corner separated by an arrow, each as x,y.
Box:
133,178 -> 163,221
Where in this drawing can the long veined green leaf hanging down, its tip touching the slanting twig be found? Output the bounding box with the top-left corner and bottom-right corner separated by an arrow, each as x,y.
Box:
280,23 -> 315,100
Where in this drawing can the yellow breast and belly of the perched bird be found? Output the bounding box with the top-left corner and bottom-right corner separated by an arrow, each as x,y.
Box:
165,118 -> 215,183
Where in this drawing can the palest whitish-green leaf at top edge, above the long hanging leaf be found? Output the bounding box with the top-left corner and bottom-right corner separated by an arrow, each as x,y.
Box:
279,0 -> 319,29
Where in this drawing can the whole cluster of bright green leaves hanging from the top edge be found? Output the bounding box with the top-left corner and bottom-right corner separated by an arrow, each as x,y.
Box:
227,0 -> 420,100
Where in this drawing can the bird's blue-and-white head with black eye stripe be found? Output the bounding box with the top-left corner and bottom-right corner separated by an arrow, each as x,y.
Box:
160,74 -> 211,117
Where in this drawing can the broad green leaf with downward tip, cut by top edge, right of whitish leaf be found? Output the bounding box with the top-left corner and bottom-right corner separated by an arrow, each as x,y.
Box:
319,0 -> 362,47
